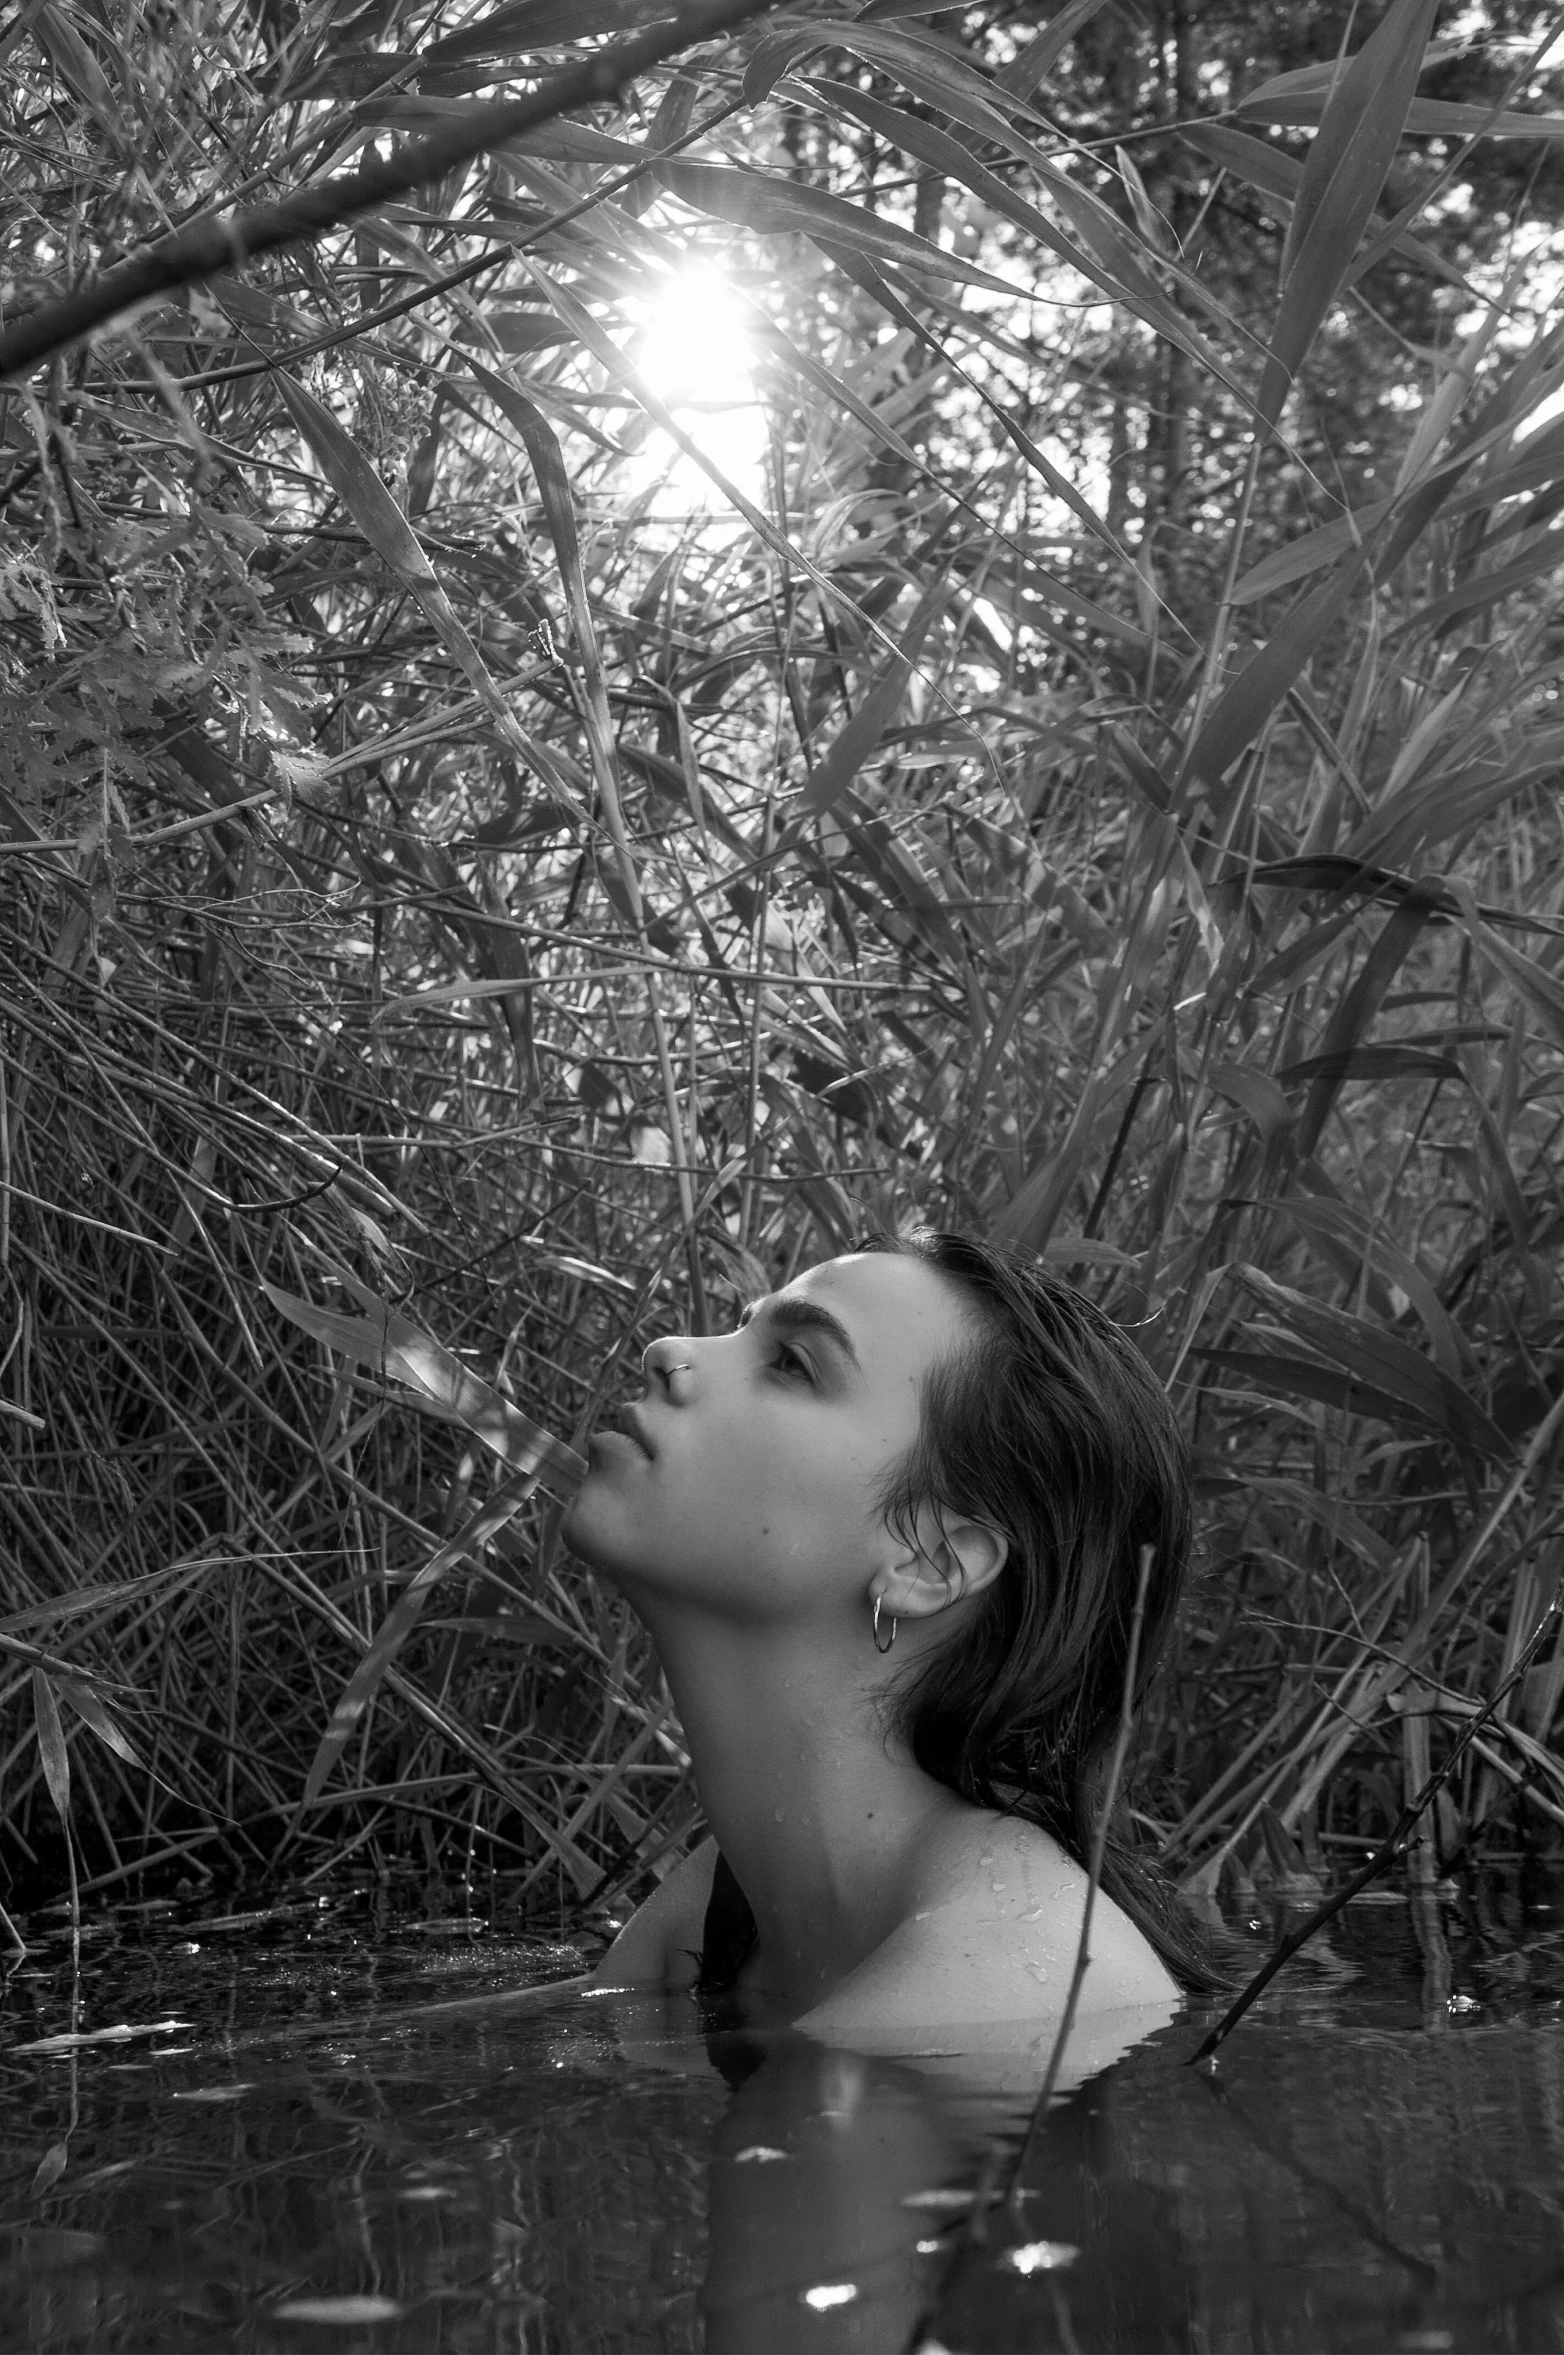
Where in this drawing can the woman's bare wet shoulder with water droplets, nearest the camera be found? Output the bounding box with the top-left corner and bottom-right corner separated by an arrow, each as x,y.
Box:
798,1809 -> 1182,2039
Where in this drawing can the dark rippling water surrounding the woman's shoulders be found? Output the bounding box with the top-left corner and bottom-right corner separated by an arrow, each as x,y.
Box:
0,1893 -> 1564,2355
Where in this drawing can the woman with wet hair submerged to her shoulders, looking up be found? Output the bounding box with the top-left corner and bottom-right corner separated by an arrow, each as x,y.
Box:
565,1234 -> 1199,2051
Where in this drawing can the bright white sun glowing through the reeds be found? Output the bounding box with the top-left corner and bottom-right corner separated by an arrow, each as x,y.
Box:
629,261 -> 766,513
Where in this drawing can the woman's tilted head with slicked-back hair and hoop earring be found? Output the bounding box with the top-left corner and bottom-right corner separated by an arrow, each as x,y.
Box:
565,1232 -> 1189,1733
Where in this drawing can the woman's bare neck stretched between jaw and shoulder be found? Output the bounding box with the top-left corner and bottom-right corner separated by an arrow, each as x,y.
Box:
652,1611 -> 961,2009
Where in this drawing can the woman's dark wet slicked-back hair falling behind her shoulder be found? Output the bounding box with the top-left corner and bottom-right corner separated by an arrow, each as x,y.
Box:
862,1229 -> 1230,1992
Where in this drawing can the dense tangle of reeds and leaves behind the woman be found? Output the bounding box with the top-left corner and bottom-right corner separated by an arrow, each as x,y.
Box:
0,0 -> 1564,1940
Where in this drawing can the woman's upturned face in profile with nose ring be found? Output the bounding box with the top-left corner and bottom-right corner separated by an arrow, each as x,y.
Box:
563,1253 -> 973,1620
